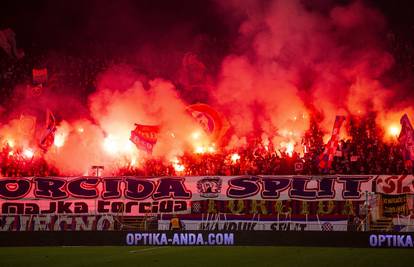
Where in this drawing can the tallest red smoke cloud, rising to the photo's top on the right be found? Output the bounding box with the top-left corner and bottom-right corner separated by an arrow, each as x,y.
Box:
214,1 -> 409,144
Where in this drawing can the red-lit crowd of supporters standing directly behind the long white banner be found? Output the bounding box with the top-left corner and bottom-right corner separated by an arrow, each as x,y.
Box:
0,119 -> 413,179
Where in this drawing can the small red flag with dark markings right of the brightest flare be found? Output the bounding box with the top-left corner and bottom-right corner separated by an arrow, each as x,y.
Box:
129,124 -> 160,154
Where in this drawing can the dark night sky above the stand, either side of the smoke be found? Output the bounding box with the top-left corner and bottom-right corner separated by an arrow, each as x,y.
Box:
0,0 -> 414,54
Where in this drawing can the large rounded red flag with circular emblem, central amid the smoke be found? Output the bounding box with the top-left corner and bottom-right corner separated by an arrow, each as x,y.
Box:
187,103 -> 229,141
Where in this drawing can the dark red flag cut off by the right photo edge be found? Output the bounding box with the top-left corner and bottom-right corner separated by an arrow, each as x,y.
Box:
398,114 -> 414,167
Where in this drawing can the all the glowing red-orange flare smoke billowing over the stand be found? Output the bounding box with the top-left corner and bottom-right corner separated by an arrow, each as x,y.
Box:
0,0 -> 414,175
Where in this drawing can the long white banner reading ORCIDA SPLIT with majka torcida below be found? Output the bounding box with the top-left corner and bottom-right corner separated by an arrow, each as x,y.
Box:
0,175 -> 374,215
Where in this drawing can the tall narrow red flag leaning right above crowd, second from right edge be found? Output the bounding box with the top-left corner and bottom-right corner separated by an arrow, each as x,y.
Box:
319,116 -> 345,169
